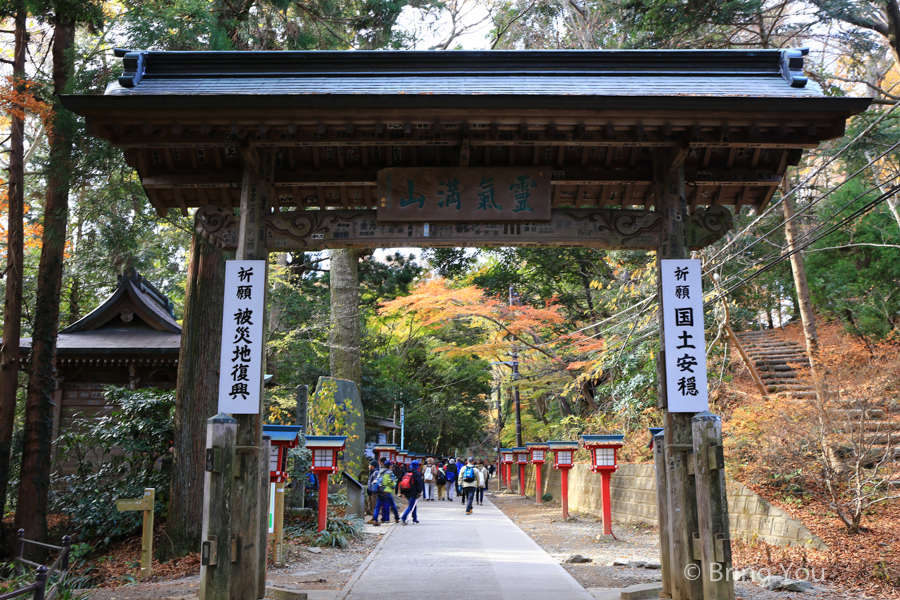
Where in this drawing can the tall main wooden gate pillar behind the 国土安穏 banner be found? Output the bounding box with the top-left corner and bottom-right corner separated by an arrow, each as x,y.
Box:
653,148 -> 703,600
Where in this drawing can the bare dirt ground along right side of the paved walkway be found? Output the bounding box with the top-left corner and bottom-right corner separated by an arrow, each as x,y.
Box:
490,494 -> 866,600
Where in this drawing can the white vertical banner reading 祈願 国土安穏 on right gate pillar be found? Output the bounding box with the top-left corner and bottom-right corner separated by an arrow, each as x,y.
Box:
660,259 -> 709,413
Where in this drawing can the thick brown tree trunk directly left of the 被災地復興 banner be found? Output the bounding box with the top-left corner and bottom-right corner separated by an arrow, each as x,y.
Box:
166,235 -> 225,556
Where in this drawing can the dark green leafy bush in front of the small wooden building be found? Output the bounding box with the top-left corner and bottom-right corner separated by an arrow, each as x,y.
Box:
51,387 -> 175,546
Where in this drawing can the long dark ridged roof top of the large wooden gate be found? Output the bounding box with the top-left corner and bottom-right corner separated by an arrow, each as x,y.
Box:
59,50 -> 868,110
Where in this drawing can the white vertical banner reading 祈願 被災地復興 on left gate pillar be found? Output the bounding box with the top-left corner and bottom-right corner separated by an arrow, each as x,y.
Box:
219,260 -> 266,415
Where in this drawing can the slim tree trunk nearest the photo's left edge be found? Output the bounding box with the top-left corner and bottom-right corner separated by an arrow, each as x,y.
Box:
0,2 -> 28,515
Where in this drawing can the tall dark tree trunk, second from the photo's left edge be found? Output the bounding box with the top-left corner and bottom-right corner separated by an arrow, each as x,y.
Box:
15,15 -> 75,562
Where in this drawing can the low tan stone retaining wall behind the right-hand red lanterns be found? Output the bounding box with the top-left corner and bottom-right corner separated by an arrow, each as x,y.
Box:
510,463 -> 827,549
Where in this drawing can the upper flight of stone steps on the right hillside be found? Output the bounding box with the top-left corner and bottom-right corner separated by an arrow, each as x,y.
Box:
735,329 -> 816,398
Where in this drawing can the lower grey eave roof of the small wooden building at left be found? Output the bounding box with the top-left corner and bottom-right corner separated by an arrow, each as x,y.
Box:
21,327 -> 181,355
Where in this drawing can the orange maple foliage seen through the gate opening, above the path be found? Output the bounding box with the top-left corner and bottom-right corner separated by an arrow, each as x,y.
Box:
380,278 -> 603,371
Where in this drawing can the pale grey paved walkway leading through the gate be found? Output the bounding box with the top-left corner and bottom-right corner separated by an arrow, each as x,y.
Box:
337,498 -> 593,600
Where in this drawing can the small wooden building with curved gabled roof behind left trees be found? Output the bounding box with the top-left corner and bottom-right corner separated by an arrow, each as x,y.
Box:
20,269 -> 181,474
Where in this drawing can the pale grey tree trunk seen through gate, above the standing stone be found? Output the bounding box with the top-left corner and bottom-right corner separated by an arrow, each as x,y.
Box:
330,249 -> 362,386
